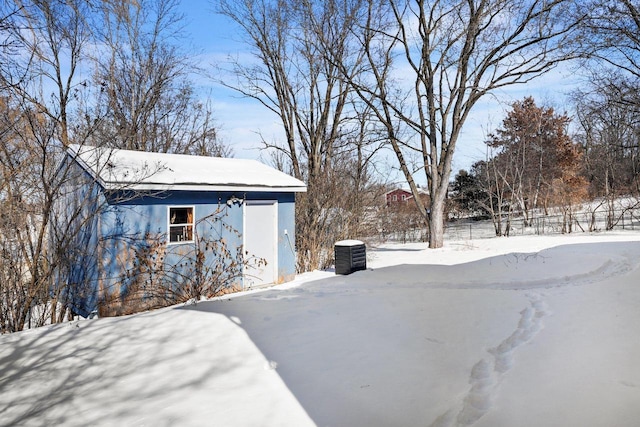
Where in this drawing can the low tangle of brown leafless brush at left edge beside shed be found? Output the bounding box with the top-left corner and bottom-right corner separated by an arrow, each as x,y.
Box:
0,92 -> 94,332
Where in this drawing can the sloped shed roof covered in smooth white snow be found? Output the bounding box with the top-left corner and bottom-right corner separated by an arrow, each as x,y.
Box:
67,144 -> 306,192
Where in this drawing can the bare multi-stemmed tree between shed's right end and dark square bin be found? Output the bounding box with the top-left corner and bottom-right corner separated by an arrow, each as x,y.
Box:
217,0 -> 379,271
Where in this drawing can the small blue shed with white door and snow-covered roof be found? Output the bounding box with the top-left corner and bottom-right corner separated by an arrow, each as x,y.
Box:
62,145 -> 306,315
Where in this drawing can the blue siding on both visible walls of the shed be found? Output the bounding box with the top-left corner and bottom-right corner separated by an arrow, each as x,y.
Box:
68,191 -> 296,315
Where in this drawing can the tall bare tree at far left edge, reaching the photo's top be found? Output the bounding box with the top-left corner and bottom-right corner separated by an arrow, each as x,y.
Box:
0,0 -> 97,331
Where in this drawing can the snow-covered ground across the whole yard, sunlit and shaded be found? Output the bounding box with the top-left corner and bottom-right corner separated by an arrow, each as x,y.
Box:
0,232 -> 640,427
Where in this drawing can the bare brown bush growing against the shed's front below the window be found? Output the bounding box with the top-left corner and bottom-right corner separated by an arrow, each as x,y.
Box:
98,206 -> 266,316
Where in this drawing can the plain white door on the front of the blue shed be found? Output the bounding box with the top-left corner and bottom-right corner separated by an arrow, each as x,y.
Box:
244,201 -> 278,287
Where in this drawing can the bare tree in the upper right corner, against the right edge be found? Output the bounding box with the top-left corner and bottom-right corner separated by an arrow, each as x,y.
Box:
574,0 -> 640,198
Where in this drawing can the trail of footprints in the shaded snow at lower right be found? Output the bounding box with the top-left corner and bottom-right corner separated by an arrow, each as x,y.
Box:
430,294 -> 549,427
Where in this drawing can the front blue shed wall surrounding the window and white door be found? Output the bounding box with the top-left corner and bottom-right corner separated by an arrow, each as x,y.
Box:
93,192 -> 295,314
